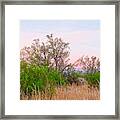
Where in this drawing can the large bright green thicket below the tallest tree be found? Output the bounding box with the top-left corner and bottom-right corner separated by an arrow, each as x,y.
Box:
20,61 -> 66,96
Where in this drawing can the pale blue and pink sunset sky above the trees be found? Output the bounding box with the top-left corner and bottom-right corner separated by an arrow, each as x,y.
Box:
20,20 -> 100,63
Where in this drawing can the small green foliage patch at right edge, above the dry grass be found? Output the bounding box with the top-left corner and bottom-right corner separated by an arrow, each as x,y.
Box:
84,72 -> 100,88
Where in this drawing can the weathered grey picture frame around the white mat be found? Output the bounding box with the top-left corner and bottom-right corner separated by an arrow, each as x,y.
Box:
0,0 -> 120,119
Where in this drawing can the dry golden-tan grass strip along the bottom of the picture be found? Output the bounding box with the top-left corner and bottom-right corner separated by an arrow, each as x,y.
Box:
21,84 -> 100,100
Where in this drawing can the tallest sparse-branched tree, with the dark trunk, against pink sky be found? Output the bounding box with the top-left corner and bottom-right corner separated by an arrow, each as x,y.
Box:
47,34 -> 69,71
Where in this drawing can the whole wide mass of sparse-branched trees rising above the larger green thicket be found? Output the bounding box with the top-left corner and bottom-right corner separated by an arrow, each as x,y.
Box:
20,34 -> 69,71
